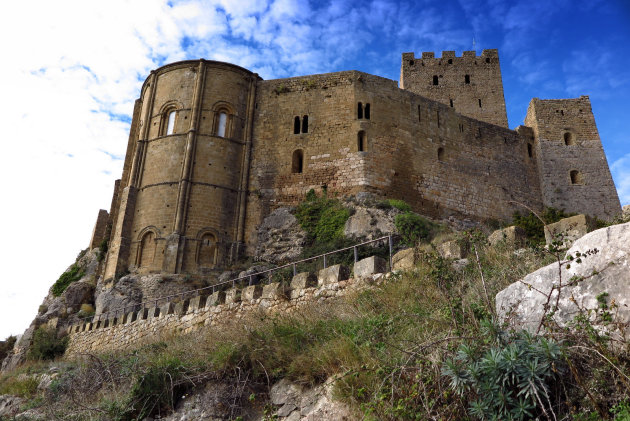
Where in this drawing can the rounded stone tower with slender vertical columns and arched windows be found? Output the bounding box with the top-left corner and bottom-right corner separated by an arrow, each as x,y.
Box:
105,60 -> 259,278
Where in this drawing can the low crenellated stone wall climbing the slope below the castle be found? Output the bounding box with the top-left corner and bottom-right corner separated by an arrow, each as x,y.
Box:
65,257 -> 388,357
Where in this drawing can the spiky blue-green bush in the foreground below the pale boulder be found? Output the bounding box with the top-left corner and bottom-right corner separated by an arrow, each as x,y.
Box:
442,322 -> 562,420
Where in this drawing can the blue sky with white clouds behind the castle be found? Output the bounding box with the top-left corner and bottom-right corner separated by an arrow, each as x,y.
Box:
0,0 -> 630,338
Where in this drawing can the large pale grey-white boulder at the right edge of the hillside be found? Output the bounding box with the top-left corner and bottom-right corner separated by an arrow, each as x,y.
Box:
496,223 -> 630,335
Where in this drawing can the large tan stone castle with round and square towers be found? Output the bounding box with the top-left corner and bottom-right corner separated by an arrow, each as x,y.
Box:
90,50 -> 621,279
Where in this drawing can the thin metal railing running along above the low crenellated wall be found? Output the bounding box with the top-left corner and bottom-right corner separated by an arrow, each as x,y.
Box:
75,234 -> 395,326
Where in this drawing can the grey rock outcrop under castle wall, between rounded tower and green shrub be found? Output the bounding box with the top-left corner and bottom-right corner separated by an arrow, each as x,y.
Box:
255,208 -> 306,263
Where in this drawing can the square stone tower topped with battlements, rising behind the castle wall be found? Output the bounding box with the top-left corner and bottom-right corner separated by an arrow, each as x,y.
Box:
400,50 -> 508,127
